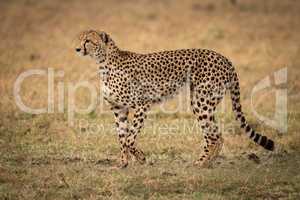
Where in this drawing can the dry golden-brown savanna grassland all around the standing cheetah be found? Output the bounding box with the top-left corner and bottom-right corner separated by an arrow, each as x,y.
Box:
0,0 -> 300,199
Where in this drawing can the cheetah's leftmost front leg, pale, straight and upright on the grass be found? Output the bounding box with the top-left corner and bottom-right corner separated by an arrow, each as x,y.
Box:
111,106 -> 129,168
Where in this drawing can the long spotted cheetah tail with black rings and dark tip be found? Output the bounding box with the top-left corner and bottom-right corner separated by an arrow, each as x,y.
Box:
230,73 -> 274,151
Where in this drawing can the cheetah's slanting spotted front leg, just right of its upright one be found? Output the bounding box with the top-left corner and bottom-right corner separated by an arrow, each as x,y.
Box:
126,105 -> 149,164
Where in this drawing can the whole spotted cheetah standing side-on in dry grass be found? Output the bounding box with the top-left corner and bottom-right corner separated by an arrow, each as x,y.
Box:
75,30 -> 274,168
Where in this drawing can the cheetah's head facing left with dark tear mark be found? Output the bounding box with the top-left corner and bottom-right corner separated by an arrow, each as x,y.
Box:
75,30 -> 112,63
